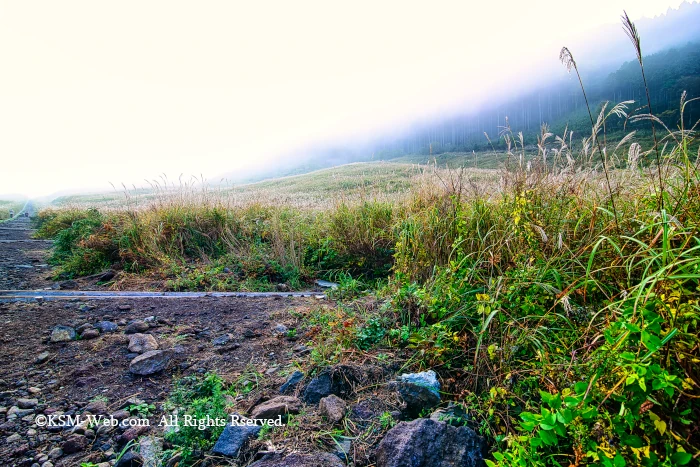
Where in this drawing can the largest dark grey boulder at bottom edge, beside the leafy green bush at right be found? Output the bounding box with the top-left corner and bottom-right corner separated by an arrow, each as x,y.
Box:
377,418 -> 485,467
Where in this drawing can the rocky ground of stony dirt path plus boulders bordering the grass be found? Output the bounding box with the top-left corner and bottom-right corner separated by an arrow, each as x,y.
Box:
0,214 -> 484,467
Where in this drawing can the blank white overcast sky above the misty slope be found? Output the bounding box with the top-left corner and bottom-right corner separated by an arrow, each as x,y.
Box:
0,0 -> 696,196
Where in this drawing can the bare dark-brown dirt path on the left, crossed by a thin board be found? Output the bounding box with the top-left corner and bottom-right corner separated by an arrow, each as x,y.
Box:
0,210 -> 325,467
